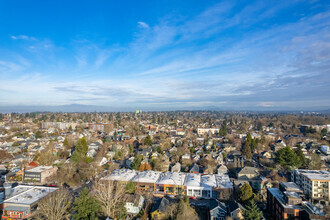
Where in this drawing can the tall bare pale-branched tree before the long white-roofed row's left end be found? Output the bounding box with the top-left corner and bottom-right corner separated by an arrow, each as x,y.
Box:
92,180 -> 125,218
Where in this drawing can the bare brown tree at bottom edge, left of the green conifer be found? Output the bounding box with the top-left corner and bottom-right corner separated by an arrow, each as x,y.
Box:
36,189 -> 72,220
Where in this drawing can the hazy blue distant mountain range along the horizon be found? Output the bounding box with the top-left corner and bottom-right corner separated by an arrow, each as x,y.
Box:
0,104 -> 330,114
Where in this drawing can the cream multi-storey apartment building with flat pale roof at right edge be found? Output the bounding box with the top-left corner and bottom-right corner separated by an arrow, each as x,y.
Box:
291,169 -> 330,205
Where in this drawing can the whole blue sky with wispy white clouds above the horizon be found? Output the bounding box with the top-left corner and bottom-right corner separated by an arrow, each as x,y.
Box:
0,0 -> 330,111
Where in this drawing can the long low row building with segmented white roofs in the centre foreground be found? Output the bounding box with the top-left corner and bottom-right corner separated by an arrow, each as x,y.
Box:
102,169 -> 233,200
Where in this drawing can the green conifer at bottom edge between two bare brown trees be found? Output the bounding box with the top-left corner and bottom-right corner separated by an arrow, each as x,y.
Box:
73,188 -> 101,220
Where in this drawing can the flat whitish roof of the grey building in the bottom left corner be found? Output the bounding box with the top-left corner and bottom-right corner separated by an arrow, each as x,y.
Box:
4,186 -> 58,205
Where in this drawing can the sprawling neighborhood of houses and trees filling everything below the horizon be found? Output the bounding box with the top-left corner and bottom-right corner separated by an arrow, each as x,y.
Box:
0,111 -> 330,220
